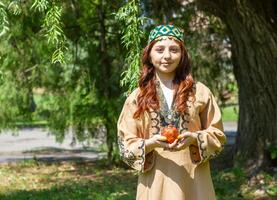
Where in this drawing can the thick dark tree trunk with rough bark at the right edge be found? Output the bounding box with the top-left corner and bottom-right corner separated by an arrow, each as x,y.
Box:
194,0 -> 277,173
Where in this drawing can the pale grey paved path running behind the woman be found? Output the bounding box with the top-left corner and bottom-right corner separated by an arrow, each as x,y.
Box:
0,122 -> 237,163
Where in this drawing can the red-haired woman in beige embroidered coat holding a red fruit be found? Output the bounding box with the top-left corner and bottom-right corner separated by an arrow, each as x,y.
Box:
118,25 -> 226,200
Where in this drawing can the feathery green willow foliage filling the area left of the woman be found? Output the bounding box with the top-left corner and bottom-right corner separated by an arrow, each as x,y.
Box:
0,0 -> 124,163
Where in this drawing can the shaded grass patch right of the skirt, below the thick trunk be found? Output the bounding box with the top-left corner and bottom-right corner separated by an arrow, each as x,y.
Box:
212,168 -> 277,200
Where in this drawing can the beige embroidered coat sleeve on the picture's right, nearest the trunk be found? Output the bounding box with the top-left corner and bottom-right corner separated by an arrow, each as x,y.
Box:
190,90 -> 226,164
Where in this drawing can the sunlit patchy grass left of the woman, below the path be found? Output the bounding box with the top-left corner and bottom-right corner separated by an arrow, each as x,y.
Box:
0,161 -> 136,200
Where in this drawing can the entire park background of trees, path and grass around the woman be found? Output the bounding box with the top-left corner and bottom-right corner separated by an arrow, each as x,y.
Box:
0,0 -> 277,200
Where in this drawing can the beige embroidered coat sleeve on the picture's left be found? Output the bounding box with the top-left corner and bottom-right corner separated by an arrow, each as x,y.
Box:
117,93 -> 153,172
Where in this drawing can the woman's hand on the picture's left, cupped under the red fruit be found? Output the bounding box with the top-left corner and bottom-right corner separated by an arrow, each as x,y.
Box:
145,134 -> 178,154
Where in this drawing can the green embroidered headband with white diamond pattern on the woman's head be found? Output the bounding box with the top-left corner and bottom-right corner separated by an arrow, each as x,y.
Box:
148,25 -> 184,44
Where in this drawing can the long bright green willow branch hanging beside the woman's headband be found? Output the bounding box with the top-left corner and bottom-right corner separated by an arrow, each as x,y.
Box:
116,0 -> 145,93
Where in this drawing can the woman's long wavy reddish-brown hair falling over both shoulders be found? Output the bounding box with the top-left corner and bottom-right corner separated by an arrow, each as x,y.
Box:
133,40 -> 194,119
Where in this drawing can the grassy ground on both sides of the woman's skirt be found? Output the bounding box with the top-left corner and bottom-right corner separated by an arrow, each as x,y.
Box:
0,161 -> 277,200
